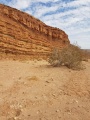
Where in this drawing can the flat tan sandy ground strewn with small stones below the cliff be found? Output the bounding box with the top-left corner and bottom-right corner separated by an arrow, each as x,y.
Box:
0,60 -> 90,120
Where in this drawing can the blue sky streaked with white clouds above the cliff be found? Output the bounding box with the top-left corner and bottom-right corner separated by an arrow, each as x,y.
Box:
0,0 -> 90,49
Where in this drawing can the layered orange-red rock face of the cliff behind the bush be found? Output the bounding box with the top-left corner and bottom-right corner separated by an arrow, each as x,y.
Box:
0,4 -> 70,58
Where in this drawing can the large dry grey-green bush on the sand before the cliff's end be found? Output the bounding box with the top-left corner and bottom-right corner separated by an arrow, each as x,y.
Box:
49,45 -> 82,69
